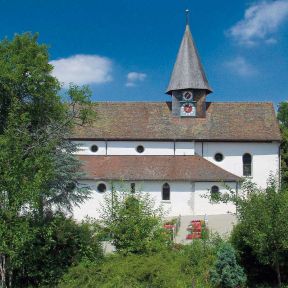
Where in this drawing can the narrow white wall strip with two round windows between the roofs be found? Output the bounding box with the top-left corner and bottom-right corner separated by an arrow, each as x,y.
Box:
74,141 -> 195,155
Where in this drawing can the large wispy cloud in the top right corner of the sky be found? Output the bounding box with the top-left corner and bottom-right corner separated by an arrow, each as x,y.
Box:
227,0 -> 288,45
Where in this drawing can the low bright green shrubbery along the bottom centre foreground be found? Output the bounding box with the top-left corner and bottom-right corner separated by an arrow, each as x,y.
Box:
59,240 -> 216,288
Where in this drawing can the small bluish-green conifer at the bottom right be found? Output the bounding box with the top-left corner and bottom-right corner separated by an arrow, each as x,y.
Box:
211,243 -> 247,288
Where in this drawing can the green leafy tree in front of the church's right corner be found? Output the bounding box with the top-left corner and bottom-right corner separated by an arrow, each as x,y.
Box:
212,177 -> 288,287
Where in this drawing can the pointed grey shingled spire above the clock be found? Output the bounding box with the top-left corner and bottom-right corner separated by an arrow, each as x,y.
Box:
166,25 -> 212,95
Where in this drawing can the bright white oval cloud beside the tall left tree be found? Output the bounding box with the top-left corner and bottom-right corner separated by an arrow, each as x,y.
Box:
50,54 -> 112,87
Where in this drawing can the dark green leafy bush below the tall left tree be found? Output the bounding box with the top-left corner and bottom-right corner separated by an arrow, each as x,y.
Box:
13,214 -> 103,287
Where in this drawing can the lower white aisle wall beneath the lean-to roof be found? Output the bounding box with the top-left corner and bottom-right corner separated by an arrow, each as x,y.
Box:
74,181 -> 236,220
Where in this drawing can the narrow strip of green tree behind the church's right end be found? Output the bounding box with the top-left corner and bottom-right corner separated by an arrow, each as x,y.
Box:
277,102 -> 288,185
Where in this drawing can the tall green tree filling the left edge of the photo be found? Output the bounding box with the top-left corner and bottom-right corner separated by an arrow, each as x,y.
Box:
0,33 -> 92,287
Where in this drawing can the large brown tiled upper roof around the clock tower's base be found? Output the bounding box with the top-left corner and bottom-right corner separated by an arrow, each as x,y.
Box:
71,102 -> 281,141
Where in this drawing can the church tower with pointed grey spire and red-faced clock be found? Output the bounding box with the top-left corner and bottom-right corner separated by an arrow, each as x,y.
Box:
166,11 -> 212,118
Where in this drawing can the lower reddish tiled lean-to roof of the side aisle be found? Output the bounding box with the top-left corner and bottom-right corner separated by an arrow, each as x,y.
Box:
78,156 -> 240,182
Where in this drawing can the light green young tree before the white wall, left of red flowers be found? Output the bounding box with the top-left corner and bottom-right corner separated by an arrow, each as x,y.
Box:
101,184 -> 169,254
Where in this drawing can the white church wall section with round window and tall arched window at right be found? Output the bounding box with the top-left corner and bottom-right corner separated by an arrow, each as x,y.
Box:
195,142 -> 279,187
